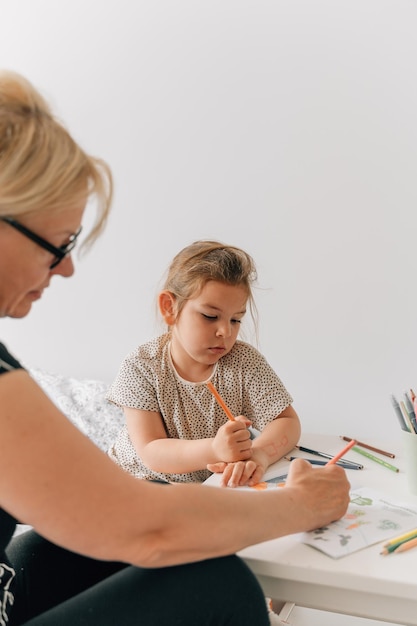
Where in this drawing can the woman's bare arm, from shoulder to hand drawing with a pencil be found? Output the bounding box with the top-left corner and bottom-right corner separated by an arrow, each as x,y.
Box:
0,370 -> 349,567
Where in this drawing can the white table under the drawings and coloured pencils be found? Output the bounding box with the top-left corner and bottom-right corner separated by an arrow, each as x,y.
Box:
204,433 -> 417,626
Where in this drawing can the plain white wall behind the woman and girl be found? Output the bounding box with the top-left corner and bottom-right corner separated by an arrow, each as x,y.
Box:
0,0 -> 417,439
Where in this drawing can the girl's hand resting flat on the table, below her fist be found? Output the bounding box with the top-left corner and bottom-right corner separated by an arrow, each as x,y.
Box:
207,449 -> 268,487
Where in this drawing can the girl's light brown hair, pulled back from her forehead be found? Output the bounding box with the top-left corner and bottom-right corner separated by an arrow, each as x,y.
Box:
163,240 -> 257,328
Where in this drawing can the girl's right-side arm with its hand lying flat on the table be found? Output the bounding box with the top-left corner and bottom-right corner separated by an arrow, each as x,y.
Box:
208,405 -> 301,487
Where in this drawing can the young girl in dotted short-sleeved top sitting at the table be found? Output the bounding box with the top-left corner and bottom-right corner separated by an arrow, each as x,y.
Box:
107,241 -> 300,487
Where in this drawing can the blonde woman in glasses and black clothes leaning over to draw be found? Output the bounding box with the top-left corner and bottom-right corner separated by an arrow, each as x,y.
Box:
0,72 -> 349,626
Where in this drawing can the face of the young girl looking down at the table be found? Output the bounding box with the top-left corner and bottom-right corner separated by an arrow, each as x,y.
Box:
167,280 -> 248,382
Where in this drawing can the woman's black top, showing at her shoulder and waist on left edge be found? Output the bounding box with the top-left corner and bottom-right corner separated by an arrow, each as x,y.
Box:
0,343 -> 22,622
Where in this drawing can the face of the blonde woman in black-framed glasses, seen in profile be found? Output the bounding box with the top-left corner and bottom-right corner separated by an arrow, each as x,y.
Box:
0,202 -> 85,318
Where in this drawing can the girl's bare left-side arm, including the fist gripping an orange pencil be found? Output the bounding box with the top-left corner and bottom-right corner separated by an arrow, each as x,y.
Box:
123,407 -> 252,473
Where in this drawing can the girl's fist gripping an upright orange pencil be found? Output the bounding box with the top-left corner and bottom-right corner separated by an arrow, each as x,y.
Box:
212,415 -> 252,463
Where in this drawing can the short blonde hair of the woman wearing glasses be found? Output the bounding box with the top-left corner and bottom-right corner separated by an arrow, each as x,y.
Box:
0,71 -> 113,246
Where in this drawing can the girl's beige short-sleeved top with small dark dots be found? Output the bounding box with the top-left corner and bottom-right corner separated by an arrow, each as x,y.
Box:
107,334 -> 292,482
